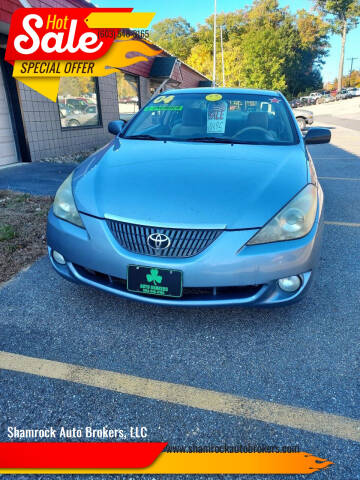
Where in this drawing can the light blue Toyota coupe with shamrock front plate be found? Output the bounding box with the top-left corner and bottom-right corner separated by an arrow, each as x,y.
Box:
47,88 -> 331,306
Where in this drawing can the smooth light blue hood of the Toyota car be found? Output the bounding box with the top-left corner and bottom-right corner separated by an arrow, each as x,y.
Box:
73,138 -> 307,229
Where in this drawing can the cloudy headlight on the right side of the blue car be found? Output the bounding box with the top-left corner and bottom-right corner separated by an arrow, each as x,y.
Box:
247,184 -> 317,245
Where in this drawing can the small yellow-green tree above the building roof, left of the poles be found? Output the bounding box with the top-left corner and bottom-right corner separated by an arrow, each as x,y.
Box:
150,17 -> 194,60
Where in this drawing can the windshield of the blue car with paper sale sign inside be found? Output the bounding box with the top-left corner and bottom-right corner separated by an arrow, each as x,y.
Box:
123,92 -> 299,145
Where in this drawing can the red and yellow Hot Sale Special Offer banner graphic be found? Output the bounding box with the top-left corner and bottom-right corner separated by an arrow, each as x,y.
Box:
5,8 -> 161,101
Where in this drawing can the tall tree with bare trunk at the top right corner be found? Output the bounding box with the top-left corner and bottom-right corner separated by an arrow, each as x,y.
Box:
314,0 -> 360,90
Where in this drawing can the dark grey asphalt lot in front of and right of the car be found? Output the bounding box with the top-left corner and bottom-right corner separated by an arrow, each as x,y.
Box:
0,109 -> 360,480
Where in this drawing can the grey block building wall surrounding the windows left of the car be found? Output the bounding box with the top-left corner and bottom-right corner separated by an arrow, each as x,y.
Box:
18,74 -> 119,161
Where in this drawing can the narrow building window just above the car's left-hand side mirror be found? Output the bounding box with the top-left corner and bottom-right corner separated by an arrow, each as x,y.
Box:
116,71 -> 140,120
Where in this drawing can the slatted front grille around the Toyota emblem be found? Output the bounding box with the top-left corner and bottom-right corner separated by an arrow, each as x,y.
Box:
107,220 -> 221,258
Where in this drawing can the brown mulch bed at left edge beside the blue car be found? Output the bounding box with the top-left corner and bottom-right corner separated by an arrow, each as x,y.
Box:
0,190 -> 53,283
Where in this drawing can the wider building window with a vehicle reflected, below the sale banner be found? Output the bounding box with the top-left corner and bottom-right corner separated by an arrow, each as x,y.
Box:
58,77 -> 102,128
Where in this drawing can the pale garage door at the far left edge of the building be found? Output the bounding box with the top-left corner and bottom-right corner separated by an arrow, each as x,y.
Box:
0,64 -> 18,166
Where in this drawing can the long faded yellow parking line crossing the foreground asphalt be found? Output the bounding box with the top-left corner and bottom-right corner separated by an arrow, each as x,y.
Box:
0,351 -> 360,442
